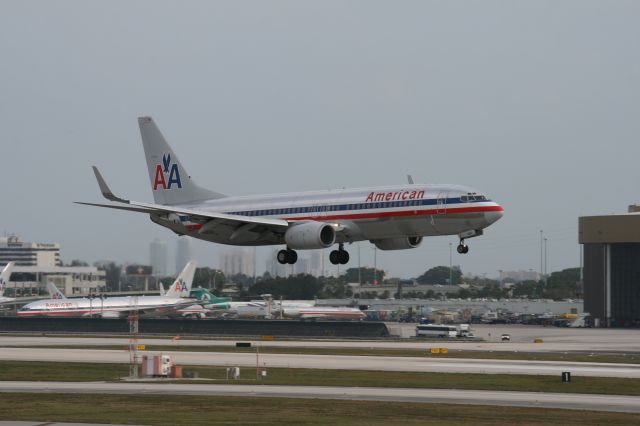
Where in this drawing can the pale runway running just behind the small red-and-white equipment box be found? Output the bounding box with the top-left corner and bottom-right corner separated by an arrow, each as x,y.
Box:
0,348 -> 640,378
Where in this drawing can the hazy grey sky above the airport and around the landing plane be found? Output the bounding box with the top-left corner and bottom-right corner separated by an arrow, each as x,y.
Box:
0,0 -> 640,277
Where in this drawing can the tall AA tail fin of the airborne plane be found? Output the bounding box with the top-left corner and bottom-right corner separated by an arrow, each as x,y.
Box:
138,117 -> 224,204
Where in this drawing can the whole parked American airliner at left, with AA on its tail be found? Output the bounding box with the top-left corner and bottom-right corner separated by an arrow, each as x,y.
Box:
18,261 -> 196,318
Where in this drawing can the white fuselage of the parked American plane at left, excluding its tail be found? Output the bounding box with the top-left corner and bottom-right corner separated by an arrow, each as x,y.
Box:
18,296 -> 193,317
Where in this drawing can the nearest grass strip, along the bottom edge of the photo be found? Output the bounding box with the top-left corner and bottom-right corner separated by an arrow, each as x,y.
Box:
0,393 -> 640,426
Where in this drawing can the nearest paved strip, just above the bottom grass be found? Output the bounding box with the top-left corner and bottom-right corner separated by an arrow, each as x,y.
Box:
0,382 -> 640,413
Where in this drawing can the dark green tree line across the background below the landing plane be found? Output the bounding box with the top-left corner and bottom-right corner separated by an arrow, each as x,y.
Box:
90,263 -> 580,300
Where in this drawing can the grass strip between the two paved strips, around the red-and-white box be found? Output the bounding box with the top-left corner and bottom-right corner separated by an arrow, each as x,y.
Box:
0,361 -> 640,396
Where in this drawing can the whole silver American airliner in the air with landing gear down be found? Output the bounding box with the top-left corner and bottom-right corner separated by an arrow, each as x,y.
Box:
78,117 -> 504,265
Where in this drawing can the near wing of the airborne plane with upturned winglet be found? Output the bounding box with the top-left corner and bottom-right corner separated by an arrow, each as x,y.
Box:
76,166 -> 289,239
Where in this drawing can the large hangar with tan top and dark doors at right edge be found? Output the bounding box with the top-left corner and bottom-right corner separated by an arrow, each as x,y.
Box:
578,206 -> 640,327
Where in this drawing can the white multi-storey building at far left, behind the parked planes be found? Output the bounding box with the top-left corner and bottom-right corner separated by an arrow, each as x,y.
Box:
0,235 -> 62,268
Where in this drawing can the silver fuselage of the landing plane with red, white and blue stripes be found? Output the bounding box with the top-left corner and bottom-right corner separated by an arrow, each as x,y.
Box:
151,184 -> 504,245
